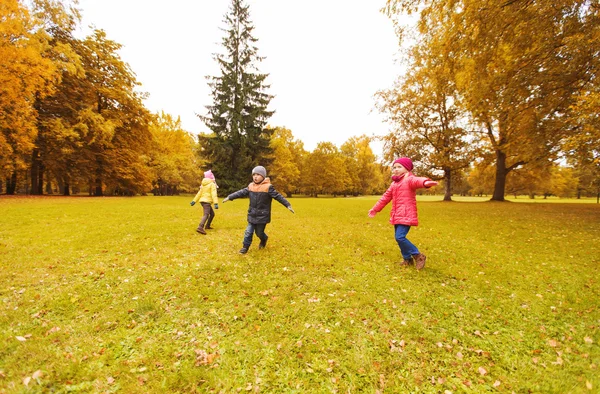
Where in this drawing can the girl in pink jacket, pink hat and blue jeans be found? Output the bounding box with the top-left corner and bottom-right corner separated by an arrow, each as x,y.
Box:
369,157 -> 437,270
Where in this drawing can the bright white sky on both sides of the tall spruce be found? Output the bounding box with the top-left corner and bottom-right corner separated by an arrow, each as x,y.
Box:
79,0 -> 400,156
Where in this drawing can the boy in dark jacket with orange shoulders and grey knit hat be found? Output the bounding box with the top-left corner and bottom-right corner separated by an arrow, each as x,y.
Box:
223,166 -> 294,254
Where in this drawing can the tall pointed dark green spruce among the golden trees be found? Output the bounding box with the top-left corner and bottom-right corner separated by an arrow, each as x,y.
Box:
199,0 -> 273,192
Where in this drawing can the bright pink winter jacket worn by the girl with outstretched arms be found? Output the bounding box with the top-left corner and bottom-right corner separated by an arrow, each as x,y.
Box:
373,172 -> 430,226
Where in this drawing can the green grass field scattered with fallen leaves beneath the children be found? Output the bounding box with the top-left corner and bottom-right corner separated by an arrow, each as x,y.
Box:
0,196 -> 600,393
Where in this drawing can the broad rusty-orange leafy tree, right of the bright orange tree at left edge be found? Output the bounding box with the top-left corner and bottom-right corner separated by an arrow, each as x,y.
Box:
32,30 -> 152,195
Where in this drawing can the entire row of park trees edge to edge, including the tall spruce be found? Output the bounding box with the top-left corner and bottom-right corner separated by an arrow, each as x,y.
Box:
0,0 -> 600,200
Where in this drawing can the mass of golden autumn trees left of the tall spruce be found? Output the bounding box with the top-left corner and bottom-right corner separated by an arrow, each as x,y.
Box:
0,0 -> 199,196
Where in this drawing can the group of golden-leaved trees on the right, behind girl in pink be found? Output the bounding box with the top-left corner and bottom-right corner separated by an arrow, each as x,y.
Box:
379,0 -> 600,201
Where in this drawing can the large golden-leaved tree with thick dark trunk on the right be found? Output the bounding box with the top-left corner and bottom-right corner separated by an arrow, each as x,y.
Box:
388,0 -> 600,201
